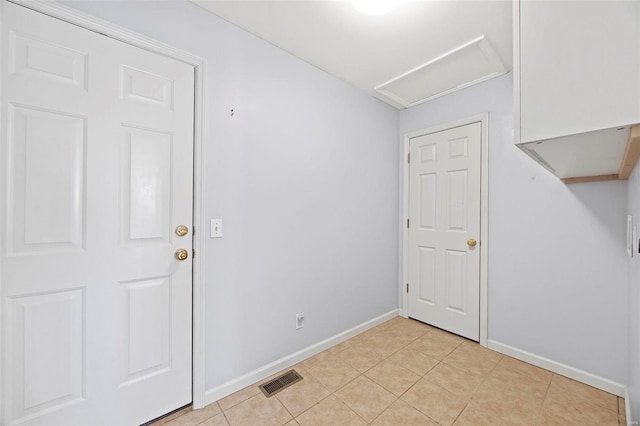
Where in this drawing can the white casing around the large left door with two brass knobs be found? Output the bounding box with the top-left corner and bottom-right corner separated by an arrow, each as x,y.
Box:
0,0 -> 207,409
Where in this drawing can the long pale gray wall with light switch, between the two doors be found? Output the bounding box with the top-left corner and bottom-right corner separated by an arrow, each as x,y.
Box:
61,1 -> 399,389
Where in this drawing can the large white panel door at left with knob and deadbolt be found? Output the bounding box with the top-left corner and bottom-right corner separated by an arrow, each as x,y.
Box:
0,3 -> 194,426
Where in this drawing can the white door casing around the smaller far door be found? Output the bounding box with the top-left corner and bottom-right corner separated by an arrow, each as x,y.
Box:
399,113 -> 489,347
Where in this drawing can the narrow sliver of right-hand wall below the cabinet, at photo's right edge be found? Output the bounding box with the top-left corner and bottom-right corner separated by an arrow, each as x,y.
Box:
627,166 -> 640,422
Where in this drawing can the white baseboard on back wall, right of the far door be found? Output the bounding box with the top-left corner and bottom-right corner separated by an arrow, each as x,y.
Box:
488,340 -> 629,396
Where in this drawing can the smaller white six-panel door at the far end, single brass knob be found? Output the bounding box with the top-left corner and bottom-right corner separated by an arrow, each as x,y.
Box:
408,123 -> 481,341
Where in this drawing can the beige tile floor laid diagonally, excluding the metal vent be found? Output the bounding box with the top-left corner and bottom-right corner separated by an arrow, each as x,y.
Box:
159,317 -> 626,426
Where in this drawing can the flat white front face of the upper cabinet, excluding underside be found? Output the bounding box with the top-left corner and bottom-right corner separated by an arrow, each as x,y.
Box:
516,1 -> 640,142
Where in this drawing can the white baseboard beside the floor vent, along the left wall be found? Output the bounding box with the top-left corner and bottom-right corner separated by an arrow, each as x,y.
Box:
205,309 -> 398,404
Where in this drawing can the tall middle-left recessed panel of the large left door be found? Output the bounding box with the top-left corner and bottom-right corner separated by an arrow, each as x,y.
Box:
8,105 -> 86,254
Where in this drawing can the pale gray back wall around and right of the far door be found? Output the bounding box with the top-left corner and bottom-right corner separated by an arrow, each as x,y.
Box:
400,75 -> 628,384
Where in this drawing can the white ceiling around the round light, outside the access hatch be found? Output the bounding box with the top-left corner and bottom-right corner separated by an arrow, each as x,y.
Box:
192,0 -> 513,108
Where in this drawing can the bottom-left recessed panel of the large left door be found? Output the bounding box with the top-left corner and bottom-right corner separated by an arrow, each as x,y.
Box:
8,289 -> 85,418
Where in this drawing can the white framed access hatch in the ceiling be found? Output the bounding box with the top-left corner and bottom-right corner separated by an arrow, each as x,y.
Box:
375,36 -> 508,108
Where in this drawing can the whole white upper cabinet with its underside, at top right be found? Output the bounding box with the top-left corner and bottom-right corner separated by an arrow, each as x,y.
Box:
514,0 -> 640,181
